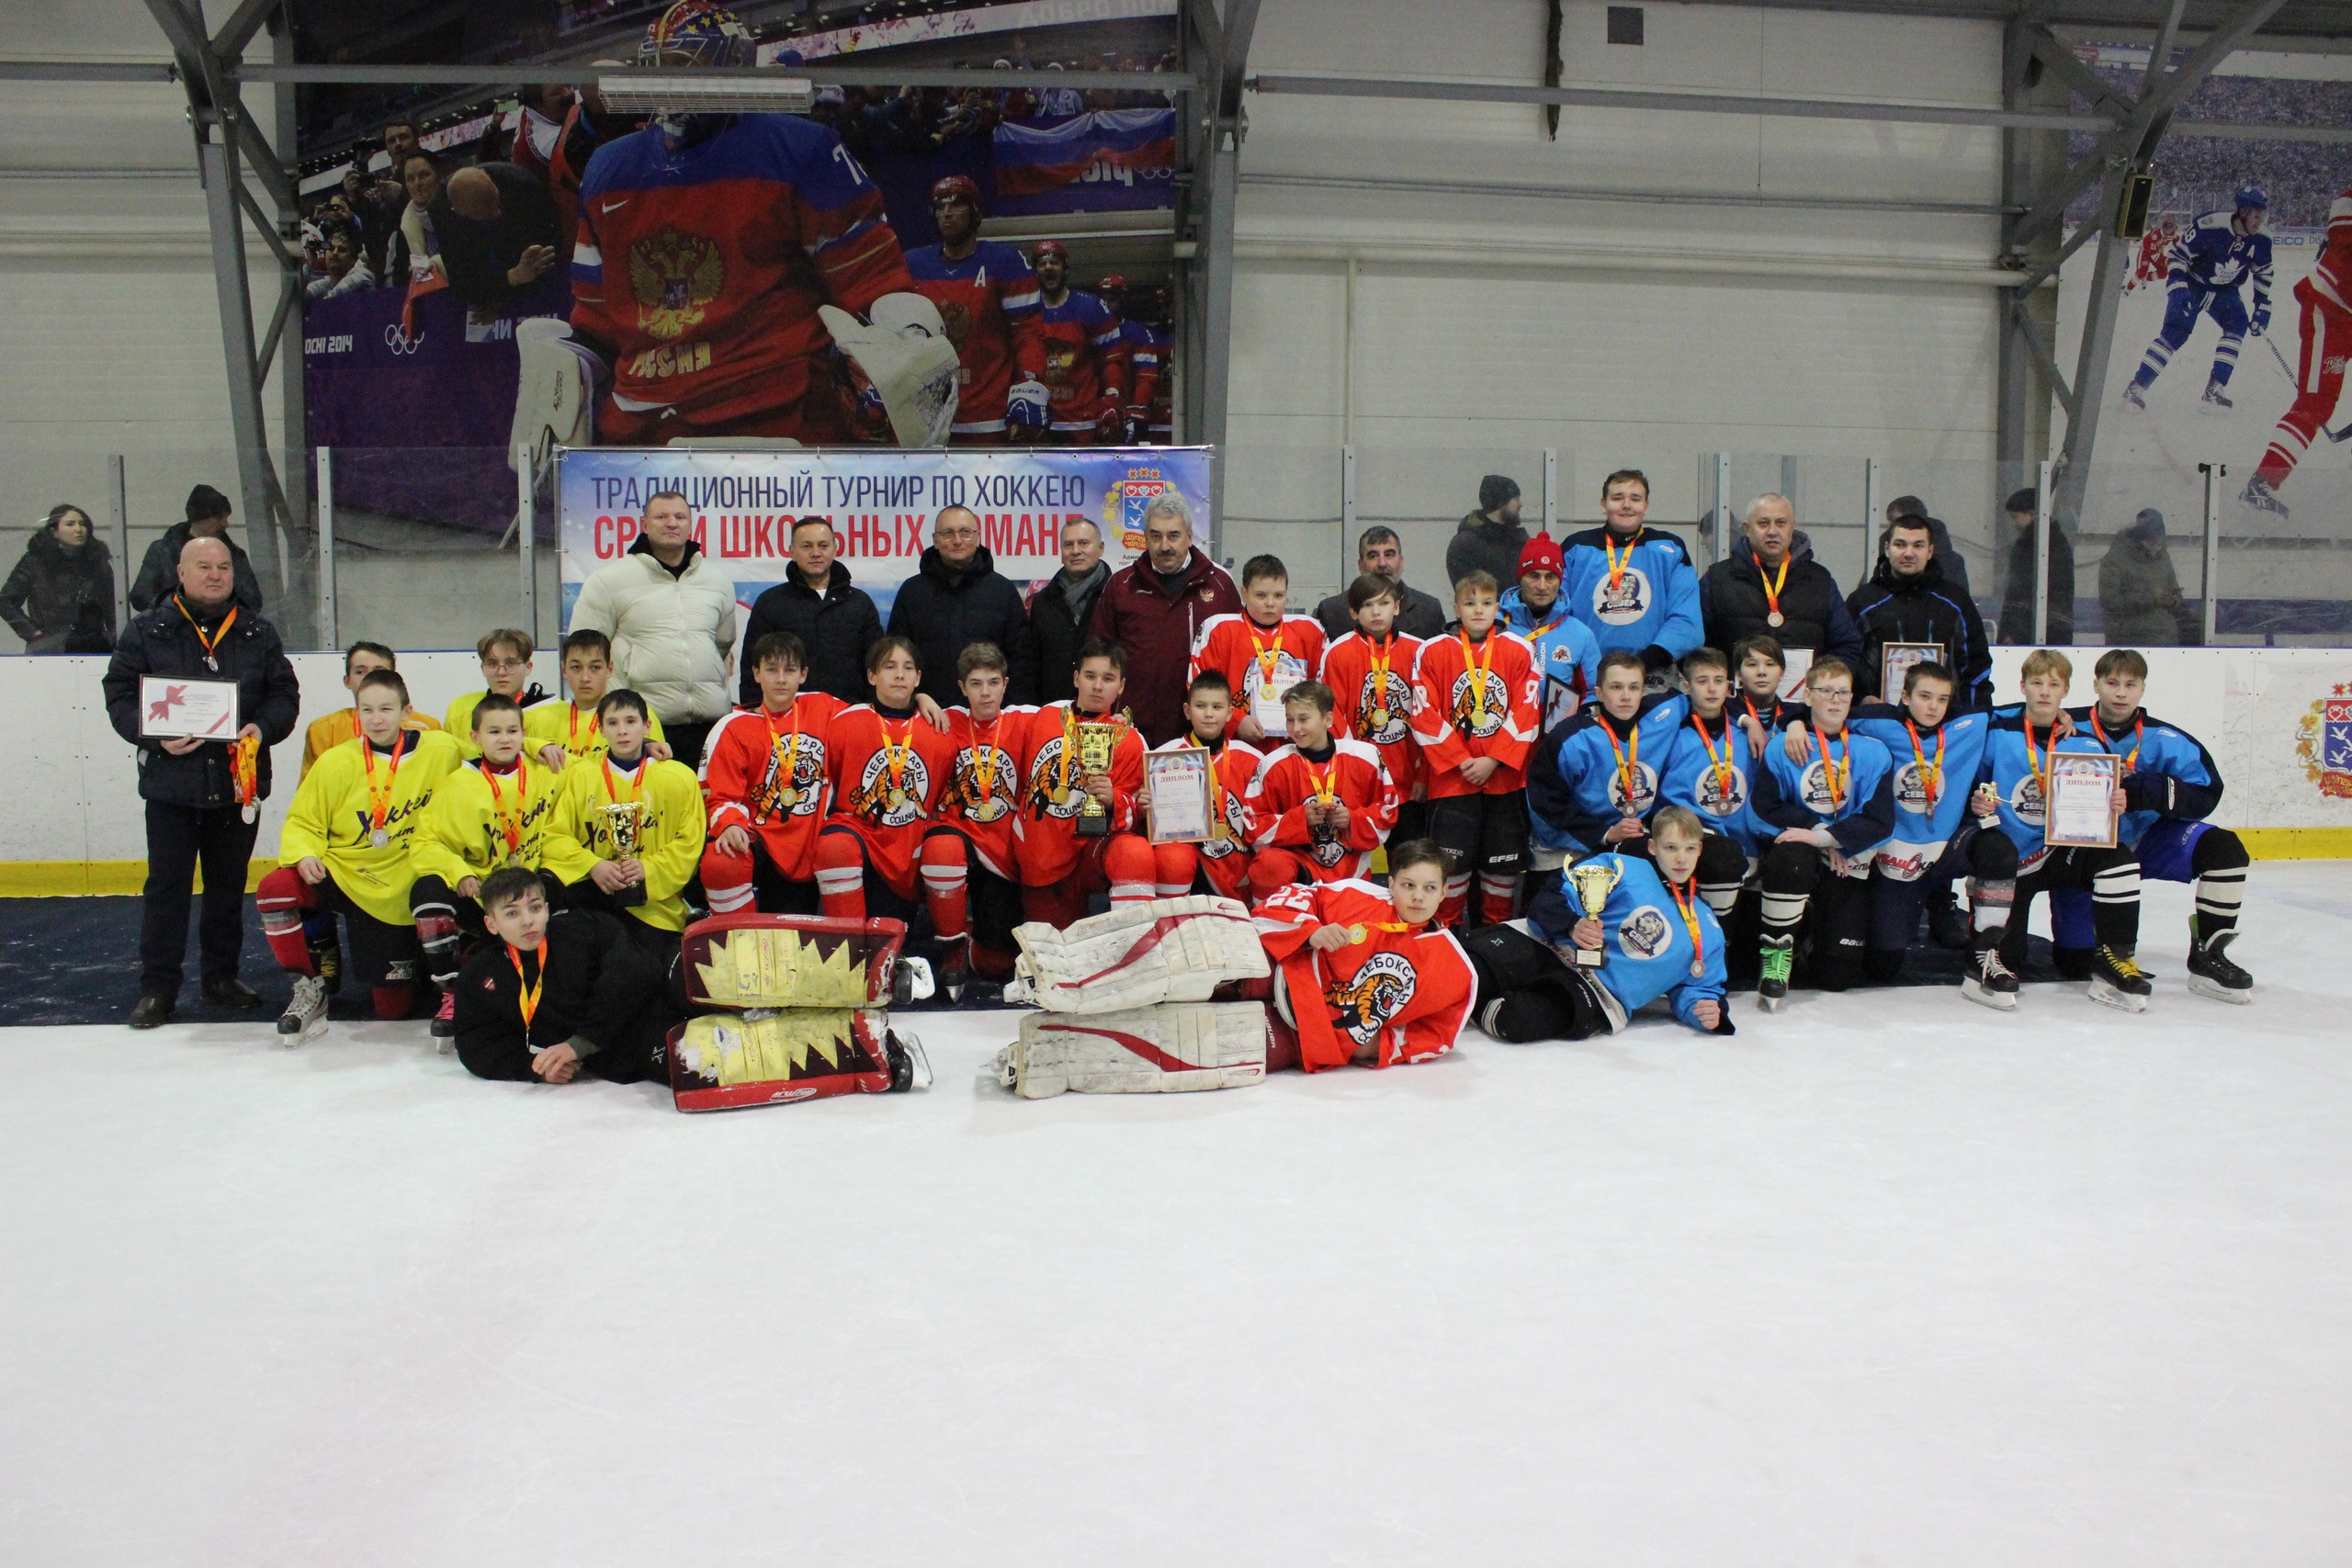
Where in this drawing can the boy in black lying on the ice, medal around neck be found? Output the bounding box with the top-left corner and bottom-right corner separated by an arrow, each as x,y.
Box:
457,865 -> 687,1084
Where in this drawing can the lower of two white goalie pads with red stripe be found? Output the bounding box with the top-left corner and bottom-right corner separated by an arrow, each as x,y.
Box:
997,1001 -> 1268,1100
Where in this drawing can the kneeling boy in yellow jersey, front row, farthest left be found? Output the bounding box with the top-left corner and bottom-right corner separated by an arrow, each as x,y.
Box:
254,670 -> 461,1046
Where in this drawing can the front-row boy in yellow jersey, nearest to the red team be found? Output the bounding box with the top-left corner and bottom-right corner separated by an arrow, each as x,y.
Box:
541,686 -> 706,957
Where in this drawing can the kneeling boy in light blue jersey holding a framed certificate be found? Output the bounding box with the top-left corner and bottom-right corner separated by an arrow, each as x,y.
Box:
1983,649 -> 2150,1013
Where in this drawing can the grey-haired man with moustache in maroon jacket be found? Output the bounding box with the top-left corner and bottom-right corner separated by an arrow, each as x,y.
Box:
1087,491 -> 1242,745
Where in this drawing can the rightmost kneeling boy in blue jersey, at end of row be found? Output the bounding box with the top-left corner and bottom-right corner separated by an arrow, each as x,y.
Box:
2051,649 -> 2253,1001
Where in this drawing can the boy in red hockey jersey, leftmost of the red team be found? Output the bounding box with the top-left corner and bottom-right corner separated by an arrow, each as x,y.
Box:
703,632 -> 844,915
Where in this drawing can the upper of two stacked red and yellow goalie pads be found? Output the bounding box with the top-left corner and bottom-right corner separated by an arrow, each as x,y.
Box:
684,912 -> 906,1009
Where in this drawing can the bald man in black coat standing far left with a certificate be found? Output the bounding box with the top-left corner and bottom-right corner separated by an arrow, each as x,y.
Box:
106,538 -> 301,1030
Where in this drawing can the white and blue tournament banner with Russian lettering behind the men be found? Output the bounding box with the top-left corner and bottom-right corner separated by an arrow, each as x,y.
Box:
555,446 -> 1216,627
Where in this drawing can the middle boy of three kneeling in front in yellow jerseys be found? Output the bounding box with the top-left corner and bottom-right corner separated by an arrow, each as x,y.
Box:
409,691 -> 558,1042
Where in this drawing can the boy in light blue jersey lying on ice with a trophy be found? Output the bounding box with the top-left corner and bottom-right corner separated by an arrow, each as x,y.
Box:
1463,807 -> 1734,1043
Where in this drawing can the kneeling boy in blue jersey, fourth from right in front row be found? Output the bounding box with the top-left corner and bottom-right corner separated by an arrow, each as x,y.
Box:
1755,653 -> 1895,1013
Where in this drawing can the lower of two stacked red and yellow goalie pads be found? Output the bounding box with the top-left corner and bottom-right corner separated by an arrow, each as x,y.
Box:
671,1006 -> 932,1112
